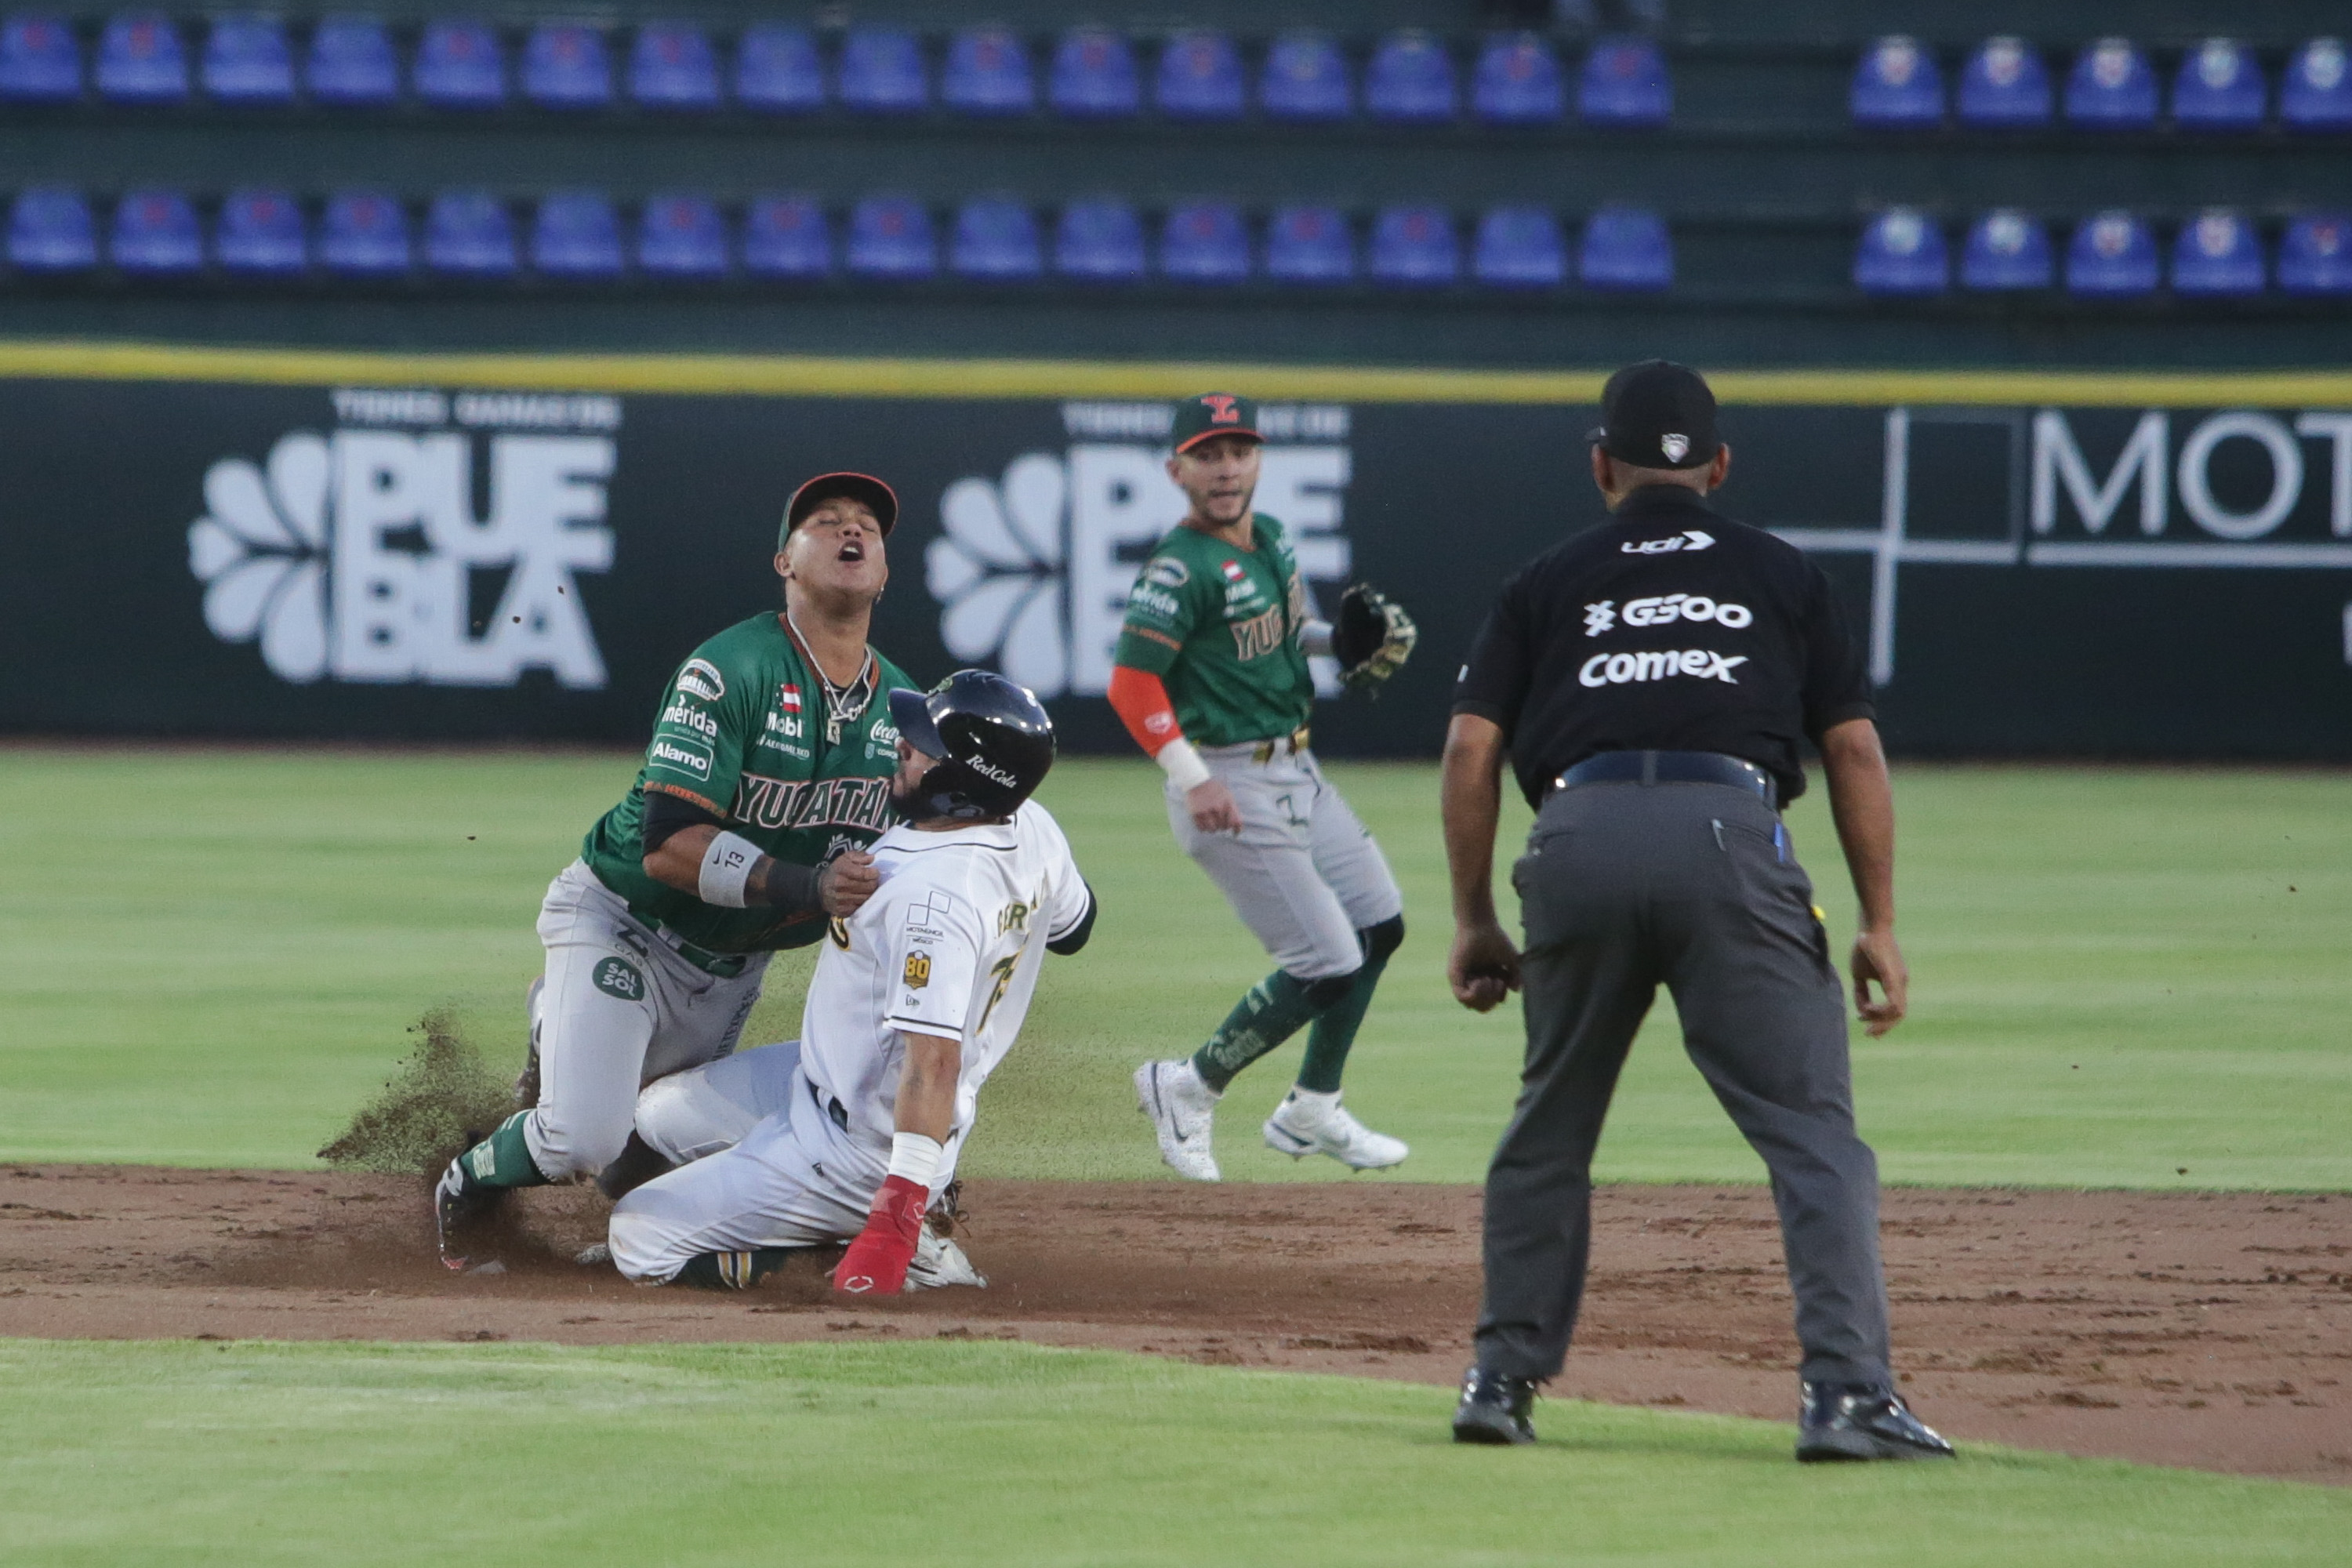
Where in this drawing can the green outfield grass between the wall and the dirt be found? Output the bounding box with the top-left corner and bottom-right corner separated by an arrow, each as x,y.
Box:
0,746 -> 2352,1187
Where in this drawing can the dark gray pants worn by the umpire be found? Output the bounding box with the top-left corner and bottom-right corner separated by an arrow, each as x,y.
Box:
1477,783 -> 1891,1382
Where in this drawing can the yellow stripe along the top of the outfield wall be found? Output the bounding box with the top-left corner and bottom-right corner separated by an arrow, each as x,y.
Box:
0,341 -> 2352,407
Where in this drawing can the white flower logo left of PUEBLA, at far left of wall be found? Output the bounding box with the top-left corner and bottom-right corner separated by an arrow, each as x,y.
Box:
188,433 -> 332,682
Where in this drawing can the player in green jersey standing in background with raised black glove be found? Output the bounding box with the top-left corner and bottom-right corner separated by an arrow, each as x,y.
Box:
1110,393 -> 1414,1182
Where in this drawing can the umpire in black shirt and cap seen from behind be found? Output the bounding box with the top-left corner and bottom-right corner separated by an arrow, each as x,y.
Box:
1444,360 -> 1952,1460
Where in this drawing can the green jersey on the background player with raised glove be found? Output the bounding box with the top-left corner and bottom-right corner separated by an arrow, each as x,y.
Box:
1117,513 -> 1315,746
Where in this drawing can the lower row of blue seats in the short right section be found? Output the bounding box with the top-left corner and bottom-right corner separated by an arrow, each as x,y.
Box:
1853,207 -> 2352,299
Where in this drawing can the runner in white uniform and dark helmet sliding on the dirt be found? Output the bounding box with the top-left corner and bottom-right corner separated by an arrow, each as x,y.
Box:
609,670 -> 1094,1295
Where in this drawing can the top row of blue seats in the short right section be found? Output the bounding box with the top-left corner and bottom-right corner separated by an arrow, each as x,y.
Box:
1851,38 -> 2352,132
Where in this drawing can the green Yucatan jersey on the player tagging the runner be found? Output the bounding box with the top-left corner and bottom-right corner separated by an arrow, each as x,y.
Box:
581,612 -> 915,952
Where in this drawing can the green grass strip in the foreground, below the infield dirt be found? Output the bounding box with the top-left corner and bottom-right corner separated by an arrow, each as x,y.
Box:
0,1342 -> 2352,1568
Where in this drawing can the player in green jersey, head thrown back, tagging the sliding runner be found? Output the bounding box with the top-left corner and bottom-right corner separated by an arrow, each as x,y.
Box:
435,473 -> 915,1267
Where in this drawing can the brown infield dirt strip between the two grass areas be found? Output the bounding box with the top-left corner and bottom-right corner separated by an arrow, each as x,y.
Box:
0,1166 -> 2352,1486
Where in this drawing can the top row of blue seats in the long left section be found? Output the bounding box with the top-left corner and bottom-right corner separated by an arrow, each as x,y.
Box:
0,12 -> 1672,125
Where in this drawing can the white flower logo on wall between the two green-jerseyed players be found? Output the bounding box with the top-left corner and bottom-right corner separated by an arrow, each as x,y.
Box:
922,452 -> 1070,699
